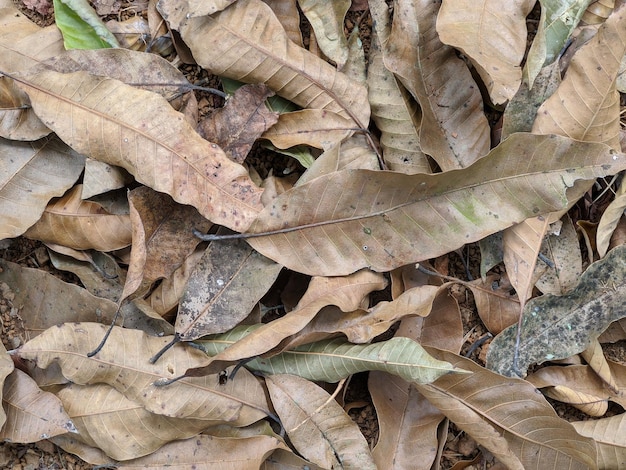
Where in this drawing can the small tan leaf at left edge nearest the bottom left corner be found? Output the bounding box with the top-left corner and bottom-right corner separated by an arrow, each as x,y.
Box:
0,369 -> 76,444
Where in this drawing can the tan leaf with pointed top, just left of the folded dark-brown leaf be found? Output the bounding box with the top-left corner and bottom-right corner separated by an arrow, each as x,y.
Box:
24,184 -> 131,251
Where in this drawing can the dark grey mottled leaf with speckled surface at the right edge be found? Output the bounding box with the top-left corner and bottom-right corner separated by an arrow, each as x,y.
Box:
487,245 -> 626,377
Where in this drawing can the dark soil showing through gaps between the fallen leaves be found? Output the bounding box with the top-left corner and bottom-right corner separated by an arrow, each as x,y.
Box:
0,0 -> 626,470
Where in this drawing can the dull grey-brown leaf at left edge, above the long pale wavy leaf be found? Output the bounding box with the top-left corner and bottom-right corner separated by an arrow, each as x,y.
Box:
0,260 -> 117,341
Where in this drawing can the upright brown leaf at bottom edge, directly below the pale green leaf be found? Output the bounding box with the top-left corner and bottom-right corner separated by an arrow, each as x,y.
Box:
367,371 -> 444,470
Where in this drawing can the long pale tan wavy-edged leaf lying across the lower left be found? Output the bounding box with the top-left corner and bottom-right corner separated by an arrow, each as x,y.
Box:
17,323 -> 269,426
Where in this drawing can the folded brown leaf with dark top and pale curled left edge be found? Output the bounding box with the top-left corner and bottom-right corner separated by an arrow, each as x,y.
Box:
121,186 -> 211,300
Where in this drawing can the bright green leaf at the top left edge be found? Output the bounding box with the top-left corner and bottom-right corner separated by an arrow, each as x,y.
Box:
54,0 -> 120,49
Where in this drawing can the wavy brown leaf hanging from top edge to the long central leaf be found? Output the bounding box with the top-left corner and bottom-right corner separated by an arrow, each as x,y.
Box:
370,0 -> 490,171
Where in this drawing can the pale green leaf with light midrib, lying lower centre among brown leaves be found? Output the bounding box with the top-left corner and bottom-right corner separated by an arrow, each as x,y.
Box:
196,327 -> 466,384
